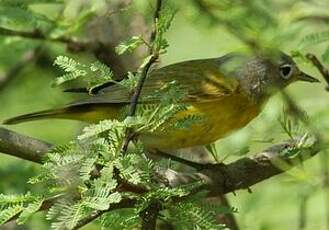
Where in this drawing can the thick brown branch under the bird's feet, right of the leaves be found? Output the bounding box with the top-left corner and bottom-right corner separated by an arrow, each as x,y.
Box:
160,141 -> 320,195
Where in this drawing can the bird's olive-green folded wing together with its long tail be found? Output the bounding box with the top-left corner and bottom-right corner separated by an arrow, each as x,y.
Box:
4,56 -> 239,124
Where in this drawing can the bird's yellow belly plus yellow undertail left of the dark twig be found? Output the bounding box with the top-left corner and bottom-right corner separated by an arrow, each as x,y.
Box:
58,94 -> 263,150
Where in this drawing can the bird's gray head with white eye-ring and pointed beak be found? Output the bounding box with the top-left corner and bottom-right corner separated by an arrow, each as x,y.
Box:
238,53 -> 319,101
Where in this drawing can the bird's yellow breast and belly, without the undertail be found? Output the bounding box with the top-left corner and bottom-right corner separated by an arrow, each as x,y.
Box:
140,94 -> 262,150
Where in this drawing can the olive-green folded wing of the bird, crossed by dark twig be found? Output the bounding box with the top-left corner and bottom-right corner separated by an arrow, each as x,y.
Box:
73,55 -> 239,104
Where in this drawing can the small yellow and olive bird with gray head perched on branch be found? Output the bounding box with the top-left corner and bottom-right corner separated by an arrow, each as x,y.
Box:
4,52 -> 319,151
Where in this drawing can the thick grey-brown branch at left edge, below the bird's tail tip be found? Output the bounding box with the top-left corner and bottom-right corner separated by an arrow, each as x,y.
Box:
0,128 -> 51,163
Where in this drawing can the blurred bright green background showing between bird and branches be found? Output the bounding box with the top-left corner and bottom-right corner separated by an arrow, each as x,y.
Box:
0,0 -> 329,230
